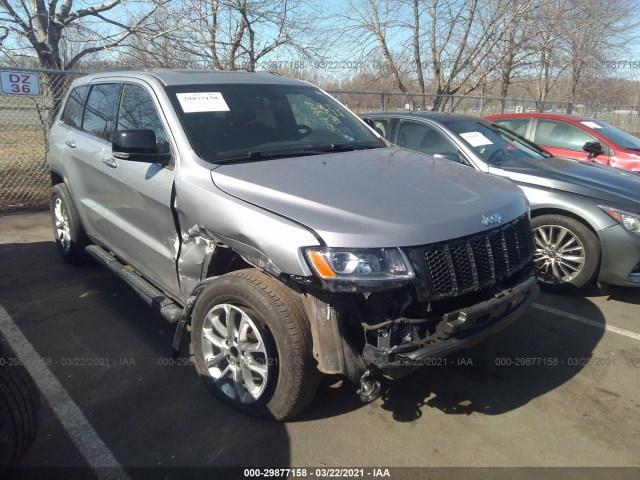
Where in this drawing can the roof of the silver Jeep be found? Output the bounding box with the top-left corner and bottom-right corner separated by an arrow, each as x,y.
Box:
74,68 -> 309,86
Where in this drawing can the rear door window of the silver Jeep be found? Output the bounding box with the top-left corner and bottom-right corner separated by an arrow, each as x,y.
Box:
82,83 -> 121,142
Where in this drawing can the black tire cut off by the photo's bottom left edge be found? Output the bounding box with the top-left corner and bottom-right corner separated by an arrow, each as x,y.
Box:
0,343 -> 40,477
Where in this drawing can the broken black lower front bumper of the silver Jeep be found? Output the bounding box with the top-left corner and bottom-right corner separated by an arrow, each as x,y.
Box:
363,276 -> 540,370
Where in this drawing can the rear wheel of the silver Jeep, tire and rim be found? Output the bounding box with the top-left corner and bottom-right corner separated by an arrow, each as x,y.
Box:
51,183 -> 90,265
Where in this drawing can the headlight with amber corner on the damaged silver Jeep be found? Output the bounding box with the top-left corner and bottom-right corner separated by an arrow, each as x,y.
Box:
305,247 -> 415,292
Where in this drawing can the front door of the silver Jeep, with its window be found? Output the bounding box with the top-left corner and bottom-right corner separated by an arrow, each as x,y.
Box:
101,83 -> 180,299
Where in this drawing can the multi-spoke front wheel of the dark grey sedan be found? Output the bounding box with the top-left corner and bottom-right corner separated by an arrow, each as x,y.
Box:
531,215 -> 601,292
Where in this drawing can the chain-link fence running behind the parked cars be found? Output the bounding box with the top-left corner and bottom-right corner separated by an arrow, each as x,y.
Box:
0,67 -> 640,215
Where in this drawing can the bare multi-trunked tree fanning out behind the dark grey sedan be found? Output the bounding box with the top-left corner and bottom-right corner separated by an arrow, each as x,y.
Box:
336,0 -> 535,109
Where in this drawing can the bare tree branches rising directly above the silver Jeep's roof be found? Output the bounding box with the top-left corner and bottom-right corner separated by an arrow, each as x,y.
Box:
128,0 -> 311,71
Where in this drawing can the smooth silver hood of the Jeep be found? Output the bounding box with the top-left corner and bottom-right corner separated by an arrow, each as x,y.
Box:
211,148 -> 527,248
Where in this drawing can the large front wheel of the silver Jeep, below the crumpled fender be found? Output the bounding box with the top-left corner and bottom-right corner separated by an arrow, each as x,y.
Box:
191,269 -> 320,420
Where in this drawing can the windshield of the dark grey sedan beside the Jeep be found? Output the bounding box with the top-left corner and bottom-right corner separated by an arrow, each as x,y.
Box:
447,120 -> 549,165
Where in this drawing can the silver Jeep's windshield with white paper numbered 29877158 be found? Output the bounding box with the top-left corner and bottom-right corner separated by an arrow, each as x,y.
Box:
167,84 -> 386,163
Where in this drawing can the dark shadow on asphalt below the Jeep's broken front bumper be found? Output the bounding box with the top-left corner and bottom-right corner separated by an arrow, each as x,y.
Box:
302,286 -> 606,422
